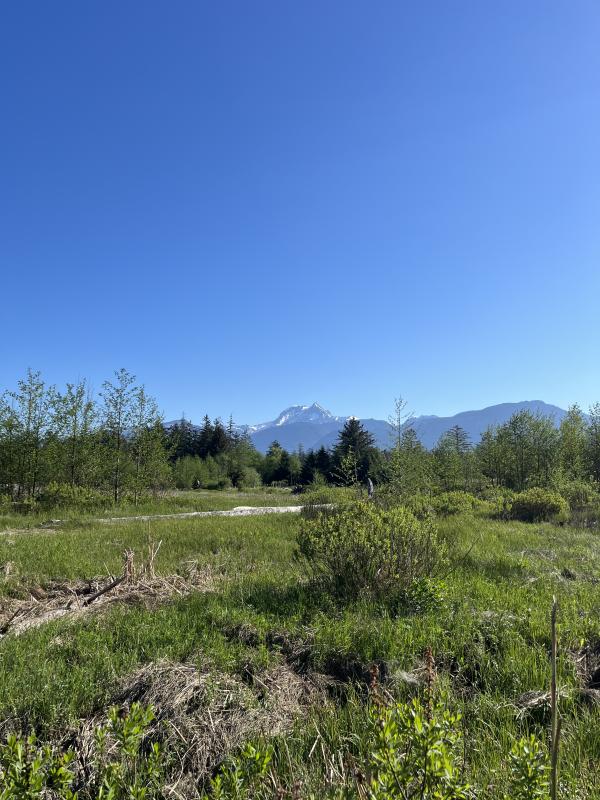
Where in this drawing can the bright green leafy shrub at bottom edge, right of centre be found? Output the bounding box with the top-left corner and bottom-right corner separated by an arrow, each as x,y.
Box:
369,699 -> 470,800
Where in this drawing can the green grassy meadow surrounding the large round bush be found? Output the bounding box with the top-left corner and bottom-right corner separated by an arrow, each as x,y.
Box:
0,493 -> 600,799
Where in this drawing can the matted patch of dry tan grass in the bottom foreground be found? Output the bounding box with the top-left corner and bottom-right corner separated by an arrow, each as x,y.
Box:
68,661 -> 322,798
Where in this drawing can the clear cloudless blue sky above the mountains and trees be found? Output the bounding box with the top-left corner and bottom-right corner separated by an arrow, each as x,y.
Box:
0,0 -> 600,422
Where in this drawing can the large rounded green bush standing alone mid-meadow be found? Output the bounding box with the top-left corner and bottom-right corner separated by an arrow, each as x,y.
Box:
298,502 -> 445,605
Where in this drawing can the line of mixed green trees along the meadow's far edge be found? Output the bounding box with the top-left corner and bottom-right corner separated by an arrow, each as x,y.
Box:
0,369 -> 600,503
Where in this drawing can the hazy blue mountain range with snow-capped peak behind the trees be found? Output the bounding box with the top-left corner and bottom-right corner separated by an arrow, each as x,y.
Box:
167,400 -> 567,453
